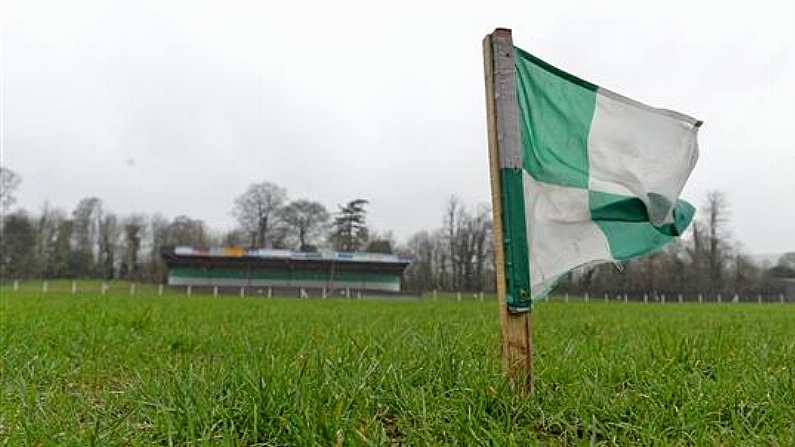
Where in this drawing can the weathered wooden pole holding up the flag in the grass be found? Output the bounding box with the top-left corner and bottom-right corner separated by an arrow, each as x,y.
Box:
483,28 -> 533,392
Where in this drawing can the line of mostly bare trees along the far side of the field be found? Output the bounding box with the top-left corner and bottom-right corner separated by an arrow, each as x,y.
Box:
0,168 -> 795,296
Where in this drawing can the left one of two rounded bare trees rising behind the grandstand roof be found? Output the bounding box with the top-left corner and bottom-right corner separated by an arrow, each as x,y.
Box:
232,182 -> 287,248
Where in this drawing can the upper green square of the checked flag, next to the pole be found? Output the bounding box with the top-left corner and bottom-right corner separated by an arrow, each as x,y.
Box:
514,48 -> 597,188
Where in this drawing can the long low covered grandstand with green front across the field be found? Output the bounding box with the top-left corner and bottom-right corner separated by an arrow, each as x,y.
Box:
161,247 -> 411,296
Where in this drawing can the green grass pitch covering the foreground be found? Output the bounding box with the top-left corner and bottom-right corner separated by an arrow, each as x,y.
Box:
0,283 -> 795,446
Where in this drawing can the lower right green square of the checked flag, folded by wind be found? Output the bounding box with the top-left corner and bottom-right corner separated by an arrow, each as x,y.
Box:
588,191 -> 695,261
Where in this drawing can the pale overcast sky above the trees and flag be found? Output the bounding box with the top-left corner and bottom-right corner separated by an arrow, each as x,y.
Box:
0,0 -> 795,253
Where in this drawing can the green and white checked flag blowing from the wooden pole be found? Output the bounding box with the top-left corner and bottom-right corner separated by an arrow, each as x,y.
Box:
501,48 -> 701,298
